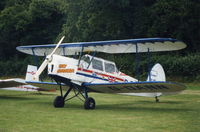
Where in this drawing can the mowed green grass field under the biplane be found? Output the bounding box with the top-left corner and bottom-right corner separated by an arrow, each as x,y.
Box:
0,84 -> 200,132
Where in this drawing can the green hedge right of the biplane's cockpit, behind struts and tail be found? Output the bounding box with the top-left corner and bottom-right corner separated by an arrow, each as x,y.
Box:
103,52 -> 200,82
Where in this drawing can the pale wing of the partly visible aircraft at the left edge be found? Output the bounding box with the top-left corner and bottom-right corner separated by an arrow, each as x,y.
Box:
0,78 -> 26,88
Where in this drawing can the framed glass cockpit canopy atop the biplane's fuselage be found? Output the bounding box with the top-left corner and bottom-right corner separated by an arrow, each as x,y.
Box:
80,55 -> 118,73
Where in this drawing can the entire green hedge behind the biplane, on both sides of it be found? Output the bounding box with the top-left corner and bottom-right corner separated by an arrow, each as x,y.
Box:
0,52 -> 200,82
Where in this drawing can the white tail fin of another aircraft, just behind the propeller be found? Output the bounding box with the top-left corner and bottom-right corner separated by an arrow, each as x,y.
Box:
26,65 -> 39,81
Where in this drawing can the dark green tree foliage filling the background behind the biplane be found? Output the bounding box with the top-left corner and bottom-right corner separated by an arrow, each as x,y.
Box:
0,0 -> 200,78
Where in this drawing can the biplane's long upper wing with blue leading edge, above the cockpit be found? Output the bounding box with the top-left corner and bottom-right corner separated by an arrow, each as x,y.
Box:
16,38 -> 186,56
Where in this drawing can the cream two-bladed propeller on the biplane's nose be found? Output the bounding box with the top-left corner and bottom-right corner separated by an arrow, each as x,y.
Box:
33,36 -> 65,81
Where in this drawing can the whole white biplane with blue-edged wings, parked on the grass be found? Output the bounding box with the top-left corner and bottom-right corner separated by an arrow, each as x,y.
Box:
16,37 -> 186,109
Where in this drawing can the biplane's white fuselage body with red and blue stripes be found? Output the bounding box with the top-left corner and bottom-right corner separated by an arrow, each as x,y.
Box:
48,55 -> 137,83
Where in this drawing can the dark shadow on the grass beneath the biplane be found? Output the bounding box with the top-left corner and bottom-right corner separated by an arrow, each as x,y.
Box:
25,94 -> 193,112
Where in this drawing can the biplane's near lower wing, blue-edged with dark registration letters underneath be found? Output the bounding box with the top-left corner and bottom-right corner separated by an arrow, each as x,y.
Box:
84,81 -> 186,93
